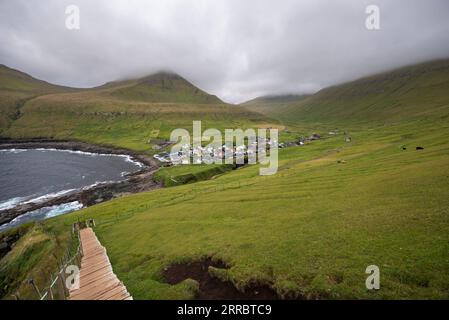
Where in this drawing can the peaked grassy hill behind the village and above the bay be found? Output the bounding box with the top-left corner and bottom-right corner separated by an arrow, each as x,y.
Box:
1,69 -> 271,151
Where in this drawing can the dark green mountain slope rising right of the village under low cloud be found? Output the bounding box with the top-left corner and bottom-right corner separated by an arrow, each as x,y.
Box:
245,59 -> 449,122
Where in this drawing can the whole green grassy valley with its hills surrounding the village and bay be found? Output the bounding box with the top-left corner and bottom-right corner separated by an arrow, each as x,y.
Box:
0,60 -> 449,299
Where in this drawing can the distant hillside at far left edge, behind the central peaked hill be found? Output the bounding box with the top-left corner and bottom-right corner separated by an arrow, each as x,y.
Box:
0,65 -> 71,135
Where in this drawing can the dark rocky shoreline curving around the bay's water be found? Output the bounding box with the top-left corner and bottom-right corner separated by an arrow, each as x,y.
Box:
0,139 -> 161,225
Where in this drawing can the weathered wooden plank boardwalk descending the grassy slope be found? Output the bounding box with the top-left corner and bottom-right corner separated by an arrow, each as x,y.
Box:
69,228 -> 132,300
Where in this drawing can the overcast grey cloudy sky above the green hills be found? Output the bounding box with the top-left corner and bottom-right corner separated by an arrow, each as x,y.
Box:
0,0 -> 449,103
